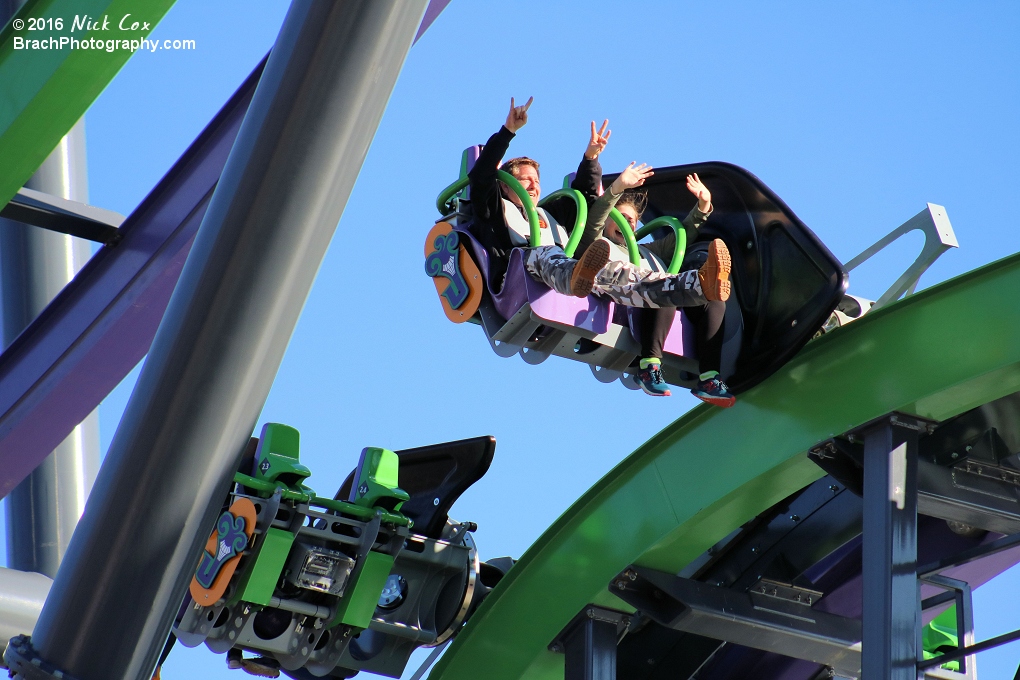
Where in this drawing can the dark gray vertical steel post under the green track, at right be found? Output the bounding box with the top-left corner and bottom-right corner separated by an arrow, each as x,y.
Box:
862,418 -> 918,680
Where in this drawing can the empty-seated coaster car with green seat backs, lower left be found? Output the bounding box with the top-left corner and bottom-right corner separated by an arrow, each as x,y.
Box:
173,423 -> 512,680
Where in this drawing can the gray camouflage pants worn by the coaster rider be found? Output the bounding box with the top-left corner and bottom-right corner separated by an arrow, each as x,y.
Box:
524,246 -> 706,309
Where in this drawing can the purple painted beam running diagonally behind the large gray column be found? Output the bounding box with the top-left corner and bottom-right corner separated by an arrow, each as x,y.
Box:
0,59 -> 265,498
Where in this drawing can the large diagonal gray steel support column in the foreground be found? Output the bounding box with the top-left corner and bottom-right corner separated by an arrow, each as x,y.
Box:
21,0 -> 425,680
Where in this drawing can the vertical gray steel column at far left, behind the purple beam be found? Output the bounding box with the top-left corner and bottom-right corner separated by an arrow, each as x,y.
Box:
0,119 -> 99,578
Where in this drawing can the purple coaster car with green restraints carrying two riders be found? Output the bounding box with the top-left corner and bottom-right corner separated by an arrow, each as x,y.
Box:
425,147 -> 848,393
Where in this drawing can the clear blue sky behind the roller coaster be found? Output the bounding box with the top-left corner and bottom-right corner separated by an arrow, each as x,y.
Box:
5,0 -> 1020,680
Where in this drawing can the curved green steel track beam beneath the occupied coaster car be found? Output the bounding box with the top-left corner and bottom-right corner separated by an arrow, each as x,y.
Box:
429,249 -> 1020,680
